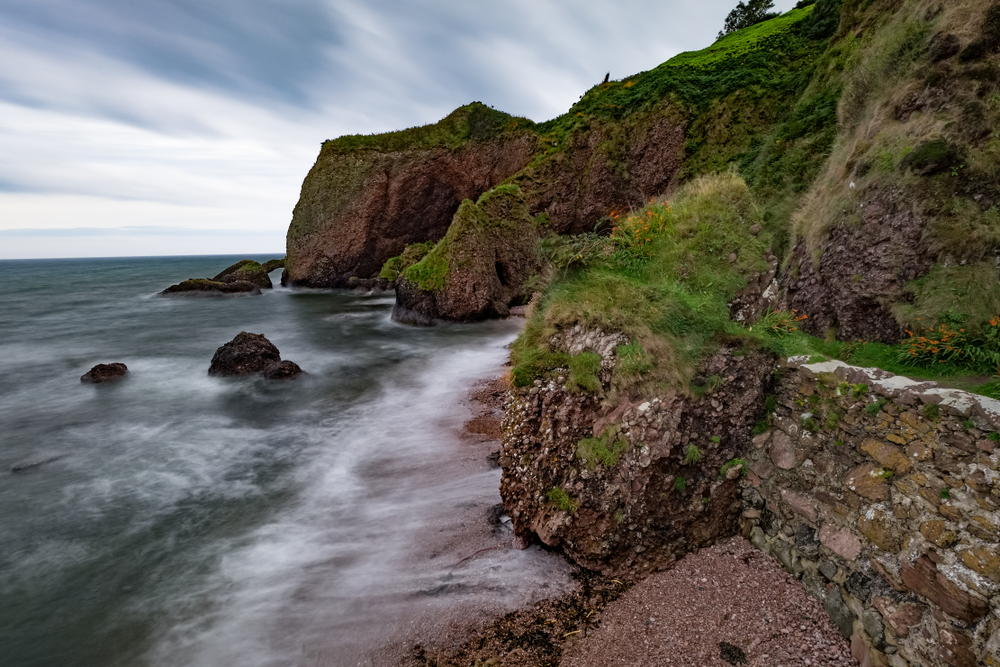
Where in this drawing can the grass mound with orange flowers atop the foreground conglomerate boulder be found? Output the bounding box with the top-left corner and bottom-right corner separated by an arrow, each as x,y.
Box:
512,172 -> 768,396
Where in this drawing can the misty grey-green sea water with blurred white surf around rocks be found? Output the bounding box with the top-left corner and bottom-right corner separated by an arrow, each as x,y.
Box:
0,257 -> 569,667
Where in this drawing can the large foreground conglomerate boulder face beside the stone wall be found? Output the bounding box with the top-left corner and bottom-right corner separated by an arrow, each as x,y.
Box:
500,330 -> 773,577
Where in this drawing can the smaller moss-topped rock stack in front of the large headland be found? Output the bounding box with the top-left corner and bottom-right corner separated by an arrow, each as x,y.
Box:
392,185 -> 539,324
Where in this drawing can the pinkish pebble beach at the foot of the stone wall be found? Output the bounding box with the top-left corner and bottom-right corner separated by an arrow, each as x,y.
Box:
560,537 -> 858,667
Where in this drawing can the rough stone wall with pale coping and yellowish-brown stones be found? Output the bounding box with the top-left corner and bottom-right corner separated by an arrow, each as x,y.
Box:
741,358 -> 1000,667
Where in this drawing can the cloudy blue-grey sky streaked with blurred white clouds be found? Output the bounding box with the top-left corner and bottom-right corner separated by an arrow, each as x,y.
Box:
0,0 -> 795,259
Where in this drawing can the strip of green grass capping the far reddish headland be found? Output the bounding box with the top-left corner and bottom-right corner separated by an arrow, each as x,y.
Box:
322,102 -> 534,153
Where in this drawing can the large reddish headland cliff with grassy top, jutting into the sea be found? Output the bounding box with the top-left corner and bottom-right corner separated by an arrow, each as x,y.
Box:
285,103 -> 536,287
